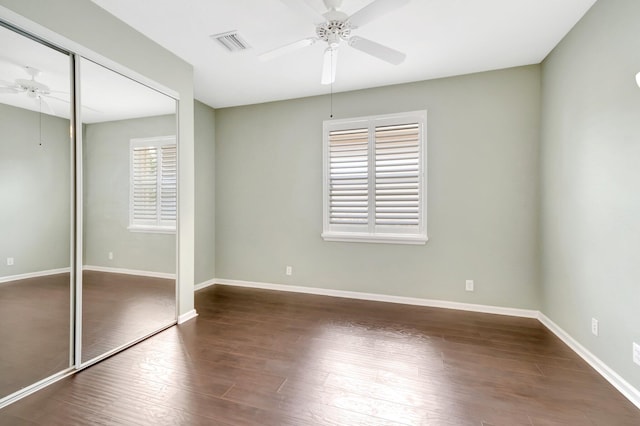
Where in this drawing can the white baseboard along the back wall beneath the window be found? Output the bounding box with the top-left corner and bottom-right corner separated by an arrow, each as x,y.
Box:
212,278 -> 538,318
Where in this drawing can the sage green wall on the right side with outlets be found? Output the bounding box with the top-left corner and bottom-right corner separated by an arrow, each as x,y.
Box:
541,0 -> 640,389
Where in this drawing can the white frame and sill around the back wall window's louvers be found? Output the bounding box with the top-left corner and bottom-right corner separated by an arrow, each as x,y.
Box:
321,110 -> 428,244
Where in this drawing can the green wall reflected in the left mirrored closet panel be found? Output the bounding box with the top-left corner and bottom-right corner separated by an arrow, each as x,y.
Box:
0,104 -> 71,279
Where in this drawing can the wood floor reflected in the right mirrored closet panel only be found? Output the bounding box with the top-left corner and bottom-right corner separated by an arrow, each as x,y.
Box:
82,271 -> 175,362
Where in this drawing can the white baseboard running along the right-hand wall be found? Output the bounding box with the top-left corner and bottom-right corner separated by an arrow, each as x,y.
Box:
538,312 -> 640,408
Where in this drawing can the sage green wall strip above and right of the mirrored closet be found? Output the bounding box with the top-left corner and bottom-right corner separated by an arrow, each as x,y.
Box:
0,0 -> 195,315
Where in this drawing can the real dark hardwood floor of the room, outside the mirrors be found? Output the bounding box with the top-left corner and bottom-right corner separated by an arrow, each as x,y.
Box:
0,286 -> 640,426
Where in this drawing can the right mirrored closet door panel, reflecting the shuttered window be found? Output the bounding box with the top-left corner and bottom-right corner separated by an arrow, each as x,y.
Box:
80,59 -> 177,363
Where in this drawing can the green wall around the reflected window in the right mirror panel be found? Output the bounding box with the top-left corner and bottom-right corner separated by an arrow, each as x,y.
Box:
83,115 -> 176,273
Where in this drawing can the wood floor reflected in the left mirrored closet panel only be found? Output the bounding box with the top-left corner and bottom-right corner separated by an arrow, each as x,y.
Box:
0,273 -> 71,396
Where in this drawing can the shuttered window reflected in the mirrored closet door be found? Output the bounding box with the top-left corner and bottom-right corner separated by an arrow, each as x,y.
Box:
129,136 -> 178,232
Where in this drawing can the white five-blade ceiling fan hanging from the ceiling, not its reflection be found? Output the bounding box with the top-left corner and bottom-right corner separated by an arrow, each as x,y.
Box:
260,0 -> 410,84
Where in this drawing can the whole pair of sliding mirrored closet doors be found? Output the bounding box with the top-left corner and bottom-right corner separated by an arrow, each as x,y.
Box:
0,21 -> 178,407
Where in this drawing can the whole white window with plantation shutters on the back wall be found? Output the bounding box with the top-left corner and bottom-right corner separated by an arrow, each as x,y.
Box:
322,111 -> 427,244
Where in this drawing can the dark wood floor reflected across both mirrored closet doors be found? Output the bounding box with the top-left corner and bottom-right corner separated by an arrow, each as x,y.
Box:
0,271 -> 175,398
